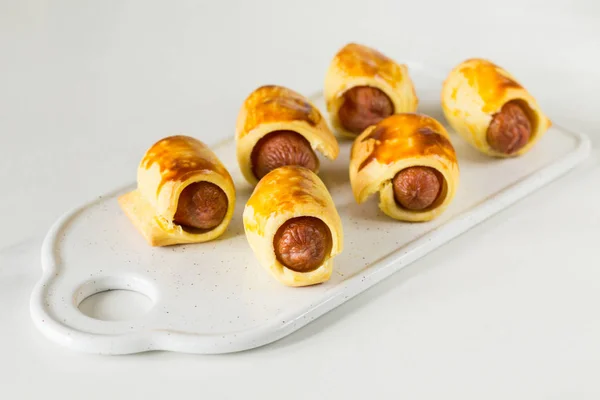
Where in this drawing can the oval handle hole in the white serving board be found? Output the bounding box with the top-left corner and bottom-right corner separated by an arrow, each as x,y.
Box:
73,277 -> 156,321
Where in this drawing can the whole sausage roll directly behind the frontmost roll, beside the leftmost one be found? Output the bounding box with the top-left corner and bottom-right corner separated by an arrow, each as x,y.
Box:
235,85 -> 339,185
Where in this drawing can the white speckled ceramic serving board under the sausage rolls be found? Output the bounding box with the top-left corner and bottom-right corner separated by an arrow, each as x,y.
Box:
31,64 -> 589,354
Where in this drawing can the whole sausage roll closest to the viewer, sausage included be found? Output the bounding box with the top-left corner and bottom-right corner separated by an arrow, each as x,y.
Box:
244,165 -> 343,286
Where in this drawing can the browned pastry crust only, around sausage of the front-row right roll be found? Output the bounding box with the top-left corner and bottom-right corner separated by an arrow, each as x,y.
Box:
350,113 -> 459,222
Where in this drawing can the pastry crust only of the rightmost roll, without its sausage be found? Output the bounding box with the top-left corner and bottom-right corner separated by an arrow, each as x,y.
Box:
442,58 -> 552,157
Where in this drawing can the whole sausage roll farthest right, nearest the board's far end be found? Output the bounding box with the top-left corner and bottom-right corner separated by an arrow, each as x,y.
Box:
442,58 -> 552,157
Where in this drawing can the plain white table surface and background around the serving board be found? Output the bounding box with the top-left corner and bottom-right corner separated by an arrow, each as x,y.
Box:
0,0 -> 600,400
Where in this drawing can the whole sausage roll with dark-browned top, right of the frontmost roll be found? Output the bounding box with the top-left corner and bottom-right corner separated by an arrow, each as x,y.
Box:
350,113 -> 459,222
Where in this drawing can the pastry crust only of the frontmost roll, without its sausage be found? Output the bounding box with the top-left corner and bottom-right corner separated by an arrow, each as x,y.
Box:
244,166 -> 343,286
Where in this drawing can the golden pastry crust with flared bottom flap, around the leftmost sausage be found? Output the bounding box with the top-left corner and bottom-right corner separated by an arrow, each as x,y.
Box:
119,135 -> 235,246
